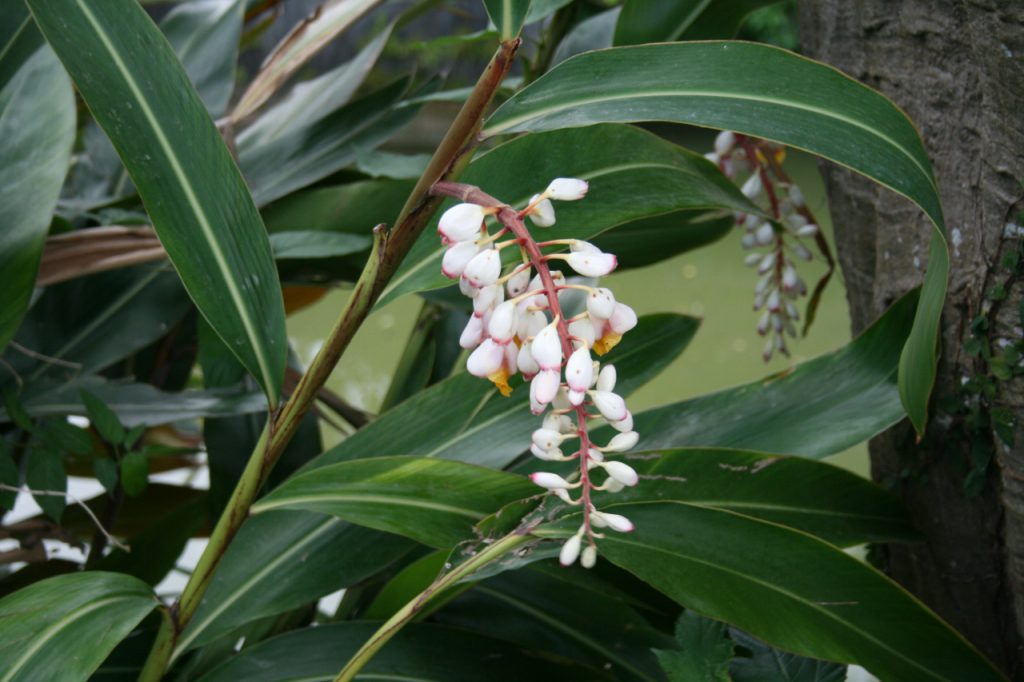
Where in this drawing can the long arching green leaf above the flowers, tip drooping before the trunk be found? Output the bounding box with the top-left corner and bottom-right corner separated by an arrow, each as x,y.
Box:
482,42 -> 949,433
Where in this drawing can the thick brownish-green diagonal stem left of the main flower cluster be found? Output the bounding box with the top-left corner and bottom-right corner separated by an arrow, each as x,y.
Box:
138,39 -> 520,682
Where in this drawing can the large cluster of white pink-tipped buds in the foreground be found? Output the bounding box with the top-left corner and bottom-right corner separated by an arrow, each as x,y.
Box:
433,178 -> 639,567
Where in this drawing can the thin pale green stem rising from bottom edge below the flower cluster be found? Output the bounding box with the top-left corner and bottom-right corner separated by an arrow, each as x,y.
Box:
334,531 -> 530,682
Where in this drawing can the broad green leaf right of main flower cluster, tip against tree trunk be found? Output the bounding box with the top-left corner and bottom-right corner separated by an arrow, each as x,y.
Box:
622,292 -> 916,458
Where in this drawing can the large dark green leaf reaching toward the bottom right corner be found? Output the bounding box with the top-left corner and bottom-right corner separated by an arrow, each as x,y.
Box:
539,502 -> 1004,682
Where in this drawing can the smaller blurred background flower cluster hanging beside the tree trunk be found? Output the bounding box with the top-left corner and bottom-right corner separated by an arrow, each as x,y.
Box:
706,130 -> 830,361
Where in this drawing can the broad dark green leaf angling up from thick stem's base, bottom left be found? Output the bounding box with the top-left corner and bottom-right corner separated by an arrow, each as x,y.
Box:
174,511 -> 414,655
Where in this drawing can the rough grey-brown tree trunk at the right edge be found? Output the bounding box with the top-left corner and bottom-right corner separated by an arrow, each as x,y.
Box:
801,0 -> 1024,679
